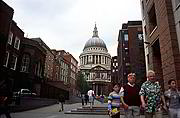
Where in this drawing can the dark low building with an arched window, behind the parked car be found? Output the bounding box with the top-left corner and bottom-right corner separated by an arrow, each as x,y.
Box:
15,38 -> 46,95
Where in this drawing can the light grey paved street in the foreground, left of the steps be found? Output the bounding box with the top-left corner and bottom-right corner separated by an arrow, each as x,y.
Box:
11,103 -> 109,118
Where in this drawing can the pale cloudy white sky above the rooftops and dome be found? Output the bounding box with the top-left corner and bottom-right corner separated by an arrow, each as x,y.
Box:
4,0 -> 141,61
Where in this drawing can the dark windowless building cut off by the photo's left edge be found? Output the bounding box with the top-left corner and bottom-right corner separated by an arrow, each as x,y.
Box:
0,0 -> 14,92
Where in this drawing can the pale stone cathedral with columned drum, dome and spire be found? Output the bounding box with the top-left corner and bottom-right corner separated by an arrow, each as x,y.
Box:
79,25 -> 111,95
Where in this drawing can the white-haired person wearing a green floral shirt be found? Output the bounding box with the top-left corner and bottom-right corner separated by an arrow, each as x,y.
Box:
139,70 -> 167,118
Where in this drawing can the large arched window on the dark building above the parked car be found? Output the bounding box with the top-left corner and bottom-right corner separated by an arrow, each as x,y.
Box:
21,54 -> 30,72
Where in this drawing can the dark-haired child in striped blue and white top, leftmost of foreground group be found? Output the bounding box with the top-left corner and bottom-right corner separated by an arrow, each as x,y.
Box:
108,84 -> 120,118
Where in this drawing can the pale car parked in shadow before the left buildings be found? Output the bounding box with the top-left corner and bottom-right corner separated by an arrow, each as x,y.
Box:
17,89 -> 37,97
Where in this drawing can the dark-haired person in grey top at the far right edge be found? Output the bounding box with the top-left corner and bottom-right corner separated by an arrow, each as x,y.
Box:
164,79 -> 180,118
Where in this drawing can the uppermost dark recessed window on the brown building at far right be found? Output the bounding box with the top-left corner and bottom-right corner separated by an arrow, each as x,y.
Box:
148,5 -> 157,32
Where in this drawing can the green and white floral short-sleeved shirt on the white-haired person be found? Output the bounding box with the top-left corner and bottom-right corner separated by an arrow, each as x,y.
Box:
139,80 -> 163,113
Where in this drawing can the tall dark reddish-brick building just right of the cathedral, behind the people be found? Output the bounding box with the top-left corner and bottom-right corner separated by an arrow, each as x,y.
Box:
117,21 -> 146,84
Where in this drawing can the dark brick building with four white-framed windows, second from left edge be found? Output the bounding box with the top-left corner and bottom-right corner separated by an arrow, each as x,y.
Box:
1,20 -> 24,91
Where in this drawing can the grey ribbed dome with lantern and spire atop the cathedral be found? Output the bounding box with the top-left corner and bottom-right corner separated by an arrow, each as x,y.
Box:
84,24 -> 107,49
